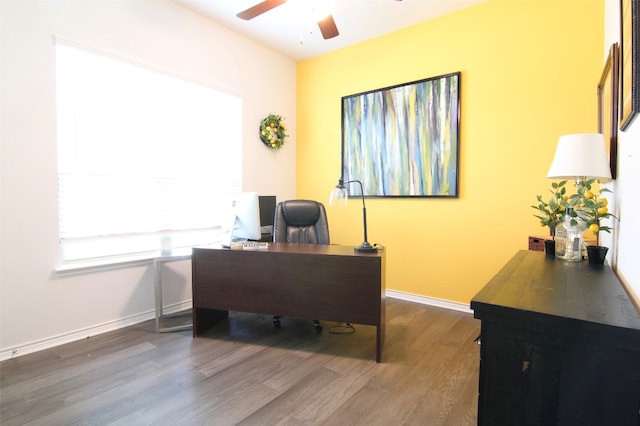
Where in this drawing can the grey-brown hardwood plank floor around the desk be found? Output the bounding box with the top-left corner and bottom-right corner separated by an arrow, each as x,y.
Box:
0,299 -> 480,426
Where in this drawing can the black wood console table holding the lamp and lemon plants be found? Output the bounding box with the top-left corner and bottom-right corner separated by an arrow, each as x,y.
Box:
471,251 -> 640,426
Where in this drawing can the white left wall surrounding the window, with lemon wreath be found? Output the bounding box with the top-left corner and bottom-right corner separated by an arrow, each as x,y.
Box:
0,0 -> 296,359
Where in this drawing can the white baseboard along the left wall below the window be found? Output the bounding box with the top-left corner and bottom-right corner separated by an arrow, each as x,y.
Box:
0,300 -> 192,361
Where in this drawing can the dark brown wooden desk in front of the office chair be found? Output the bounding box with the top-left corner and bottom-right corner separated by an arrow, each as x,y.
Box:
191,243 -> 386,362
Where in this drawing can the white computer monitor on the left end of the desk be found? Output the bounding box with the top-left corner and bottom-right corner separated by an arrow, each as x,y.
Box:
222,192 -> 262,247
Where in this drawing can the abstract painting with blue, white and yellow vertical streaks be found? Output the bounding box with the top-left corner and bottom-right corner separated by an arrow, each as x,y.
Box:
342,72 -> 460,197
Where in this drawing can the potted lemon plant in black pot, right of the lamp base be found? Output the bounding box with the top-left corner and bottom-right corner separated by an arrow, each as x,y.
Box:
569,179 -> 616,264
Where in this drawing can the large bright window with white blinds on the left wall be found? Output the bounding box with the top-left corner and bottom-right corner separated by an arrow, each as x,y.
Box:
56,42 -> 242,264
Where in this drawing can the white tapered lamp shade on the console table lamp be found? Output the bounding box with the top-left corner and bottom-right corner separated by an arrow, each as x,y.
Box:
547,133 -> 611,179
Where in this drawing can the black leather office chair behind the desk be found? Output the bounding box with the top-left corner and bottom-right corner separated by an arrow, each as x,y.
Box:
273,200 -> 330,333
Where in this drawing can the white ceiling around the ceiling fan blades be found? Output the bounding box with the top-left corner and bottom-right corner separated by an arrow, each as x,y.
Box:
174,0 -> 487,61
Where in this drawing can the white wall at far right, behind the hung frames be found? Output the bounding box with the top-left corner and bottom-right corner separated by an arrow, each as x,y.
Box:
603,0 -> 640,304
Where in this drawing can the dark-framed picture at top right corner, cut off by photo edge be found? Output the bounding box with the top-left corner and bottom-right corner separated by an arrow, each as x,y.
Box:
620,0 -> 640,131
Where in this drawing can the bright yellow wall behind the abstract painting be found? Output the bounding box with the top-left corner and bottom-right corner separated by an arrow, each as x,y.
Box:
296,0 -> 604,303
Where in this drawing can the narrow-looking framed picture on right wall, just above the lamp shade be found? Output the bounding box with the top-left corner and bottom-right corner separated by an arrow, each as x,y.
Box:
598,43 -> 620,179
